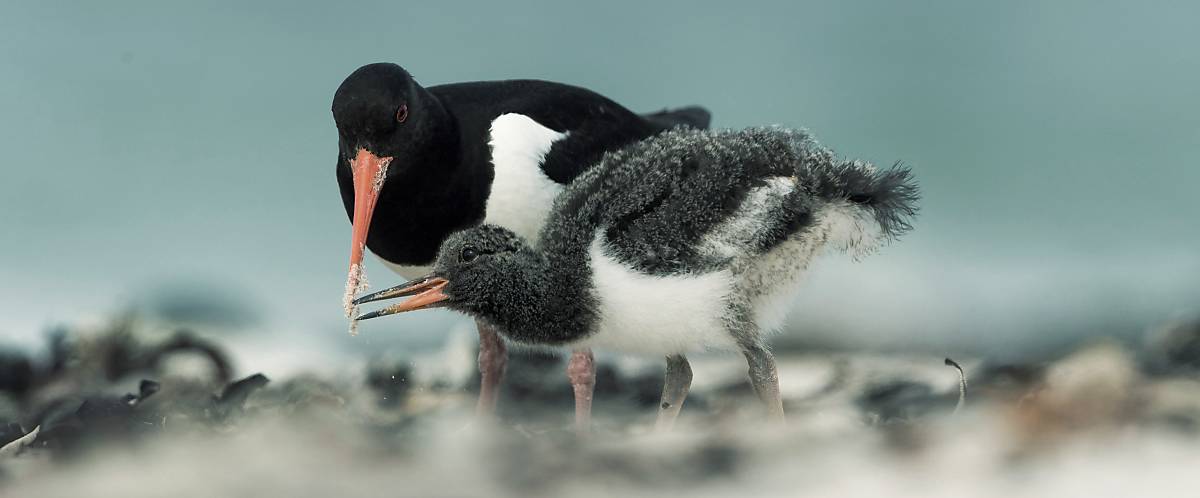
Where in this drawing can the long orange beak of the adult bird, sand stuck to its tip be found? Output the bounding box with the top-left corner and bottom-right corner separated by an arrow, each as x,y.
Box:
343,148 -> 391,316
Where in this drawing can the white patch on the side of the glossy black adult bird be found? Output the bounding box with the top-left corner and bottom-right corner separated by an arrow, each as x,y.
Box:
484,114 -> 568,244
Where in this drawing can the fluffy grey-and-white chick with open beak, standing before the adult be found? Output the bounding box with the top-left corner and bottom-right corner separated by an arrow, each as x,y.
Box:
356,128 -> 918,431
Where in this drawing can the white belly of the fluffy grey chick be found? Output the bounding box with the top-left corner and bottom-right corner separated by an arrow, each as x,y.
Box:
578,234 -> 737,354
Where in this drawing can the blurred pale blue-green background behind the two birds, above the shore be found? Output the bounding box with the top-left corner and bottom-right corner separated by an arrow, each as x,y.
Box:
0,0 -> 1200,373
